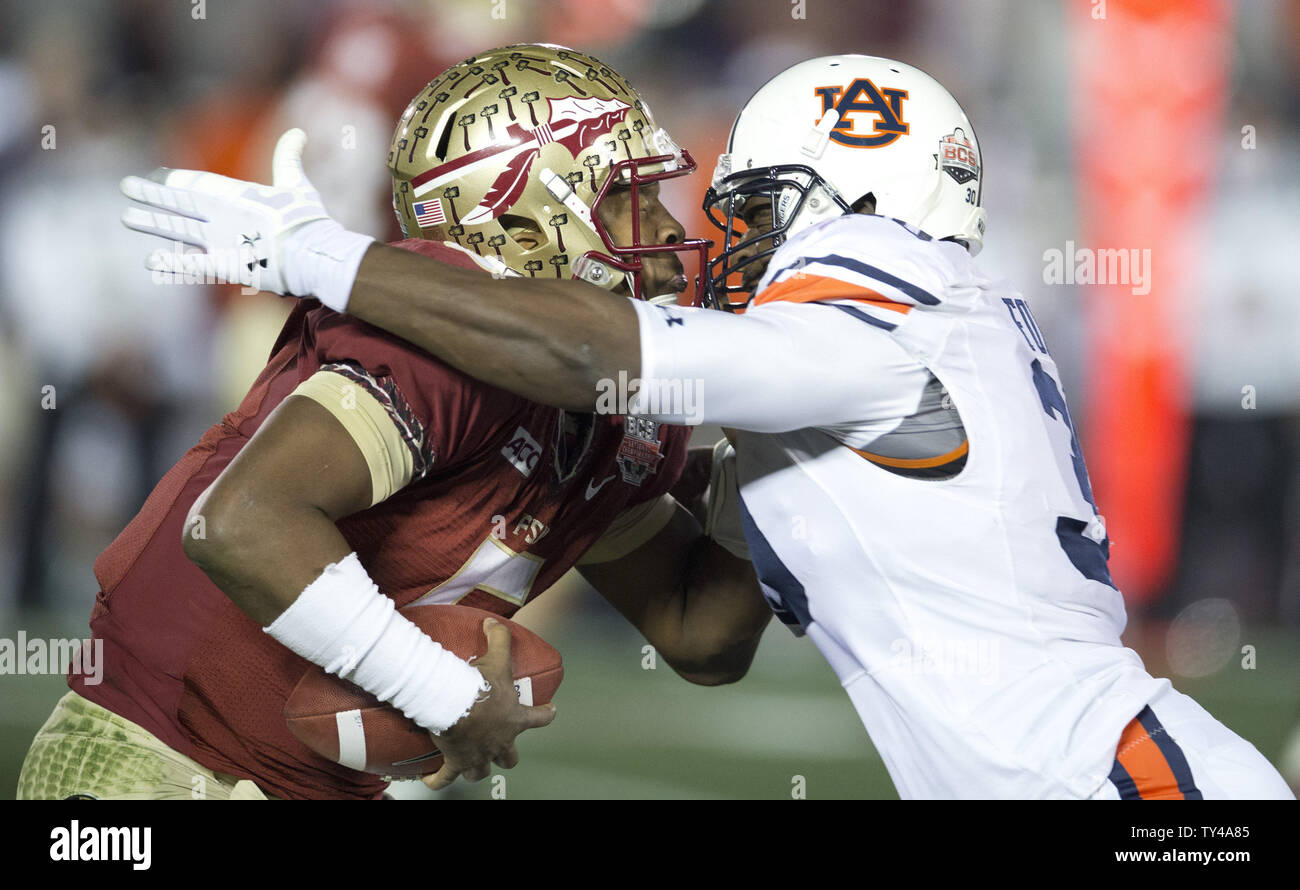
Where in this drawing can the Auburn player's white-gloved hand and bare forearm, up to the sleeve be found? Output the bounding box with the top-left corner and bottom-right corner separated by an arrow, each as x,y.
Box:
121,129 -> 640,411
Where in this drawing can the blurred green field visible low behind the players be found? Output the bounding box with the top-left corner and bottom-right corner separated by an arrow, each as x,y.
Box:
0,585 -> 1300,799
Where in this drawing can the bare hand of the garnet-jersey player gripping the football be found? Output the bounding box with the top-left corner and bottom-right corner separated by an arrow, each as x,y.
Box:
424,618 -> 555,791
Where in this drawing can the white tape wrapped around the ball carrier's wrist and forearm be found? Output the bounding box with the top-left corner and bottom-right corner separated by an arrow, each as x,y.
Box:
265,553 -> 491,733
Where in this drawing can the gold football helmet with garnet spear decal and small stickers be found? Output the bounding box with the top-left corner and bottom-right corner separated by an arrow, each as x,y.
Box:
387,44 -> 711,303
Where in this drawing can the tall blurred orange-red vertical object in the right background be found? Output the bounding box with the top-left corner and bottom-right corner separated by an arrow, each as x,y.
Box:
1067,0 -> 1232,604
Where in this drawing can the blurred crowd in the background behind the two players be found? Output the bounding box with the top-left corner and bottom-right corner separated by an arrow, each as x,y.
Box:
0,0 -> 1300,639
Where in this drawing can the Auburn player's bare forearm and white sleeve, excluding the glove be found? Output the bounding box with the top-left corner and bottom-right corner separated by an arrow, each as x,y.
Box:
347,252 -> 904,433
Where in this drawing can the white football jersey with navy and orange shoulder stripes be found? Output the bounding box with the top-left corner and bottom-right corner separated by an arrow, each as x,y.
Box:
637,214 -> 1169,798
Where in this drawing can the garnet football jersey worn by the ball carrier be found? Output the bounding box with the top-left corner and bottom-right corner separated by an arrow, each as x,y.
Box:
69,242 -> 689,798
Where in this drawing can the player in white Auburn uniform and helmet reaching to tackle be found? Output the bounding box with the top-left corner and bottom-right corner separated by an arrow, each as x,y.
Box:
126,56 -> 1292,799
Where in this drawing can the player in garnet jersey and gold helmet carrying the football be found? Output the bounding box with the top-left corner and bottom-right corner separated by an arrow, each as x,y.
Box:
18,45 -> 770,798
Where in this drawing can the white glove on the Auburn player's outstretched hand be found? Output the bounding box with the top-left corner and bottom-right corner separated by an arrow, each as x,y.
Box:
122,127 -> 374,312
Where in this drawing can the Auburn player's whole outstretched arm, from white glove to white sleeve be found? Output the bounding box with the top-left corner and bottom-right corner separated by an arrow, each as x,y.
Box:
122,130 -> 901,431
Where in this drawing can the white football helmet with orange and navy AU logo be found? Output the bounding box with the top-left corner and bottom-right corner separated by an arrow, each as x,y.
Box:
705,55 -> 985,309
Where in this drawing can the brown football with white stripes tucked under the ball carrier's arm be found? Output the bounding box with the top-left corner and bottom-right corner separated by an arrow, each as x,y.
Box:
285,605 -> 564,777
